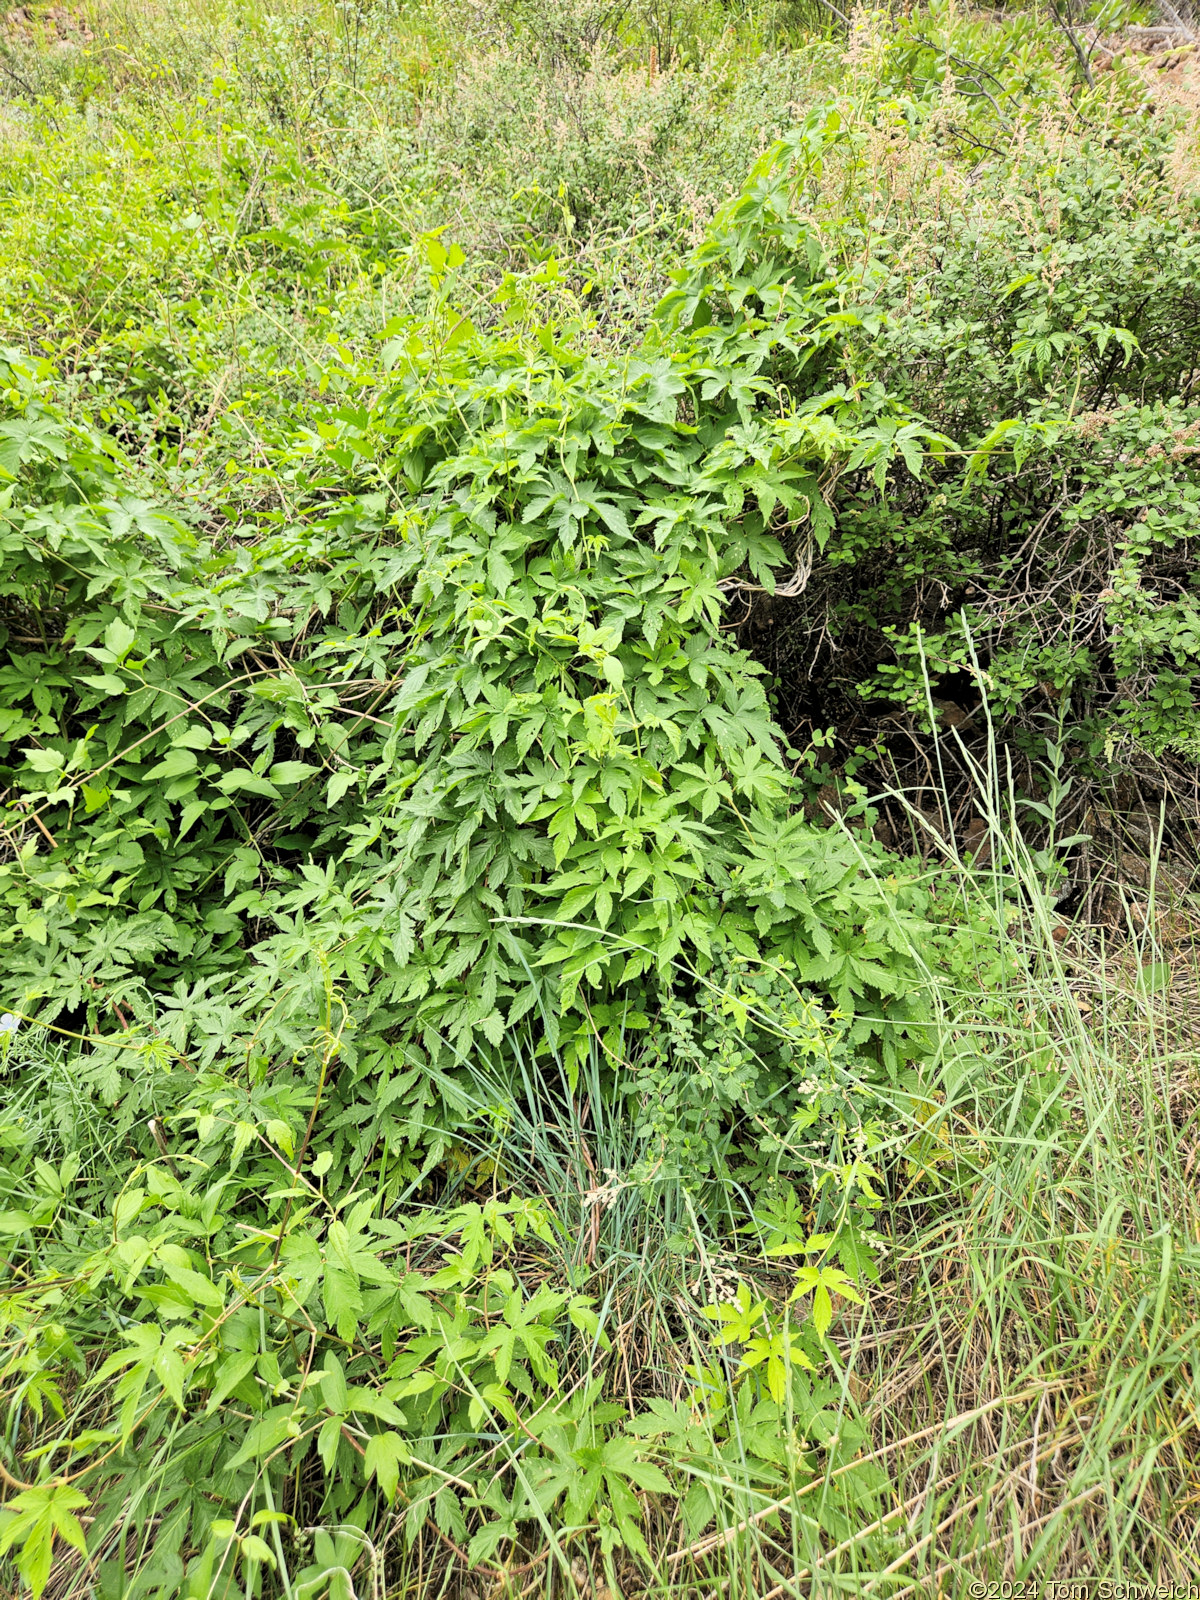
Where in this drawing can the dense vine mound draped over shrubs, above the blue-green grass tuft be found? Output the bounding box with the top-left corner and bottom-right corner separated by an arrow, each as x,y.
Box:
0,115 -> 985,1160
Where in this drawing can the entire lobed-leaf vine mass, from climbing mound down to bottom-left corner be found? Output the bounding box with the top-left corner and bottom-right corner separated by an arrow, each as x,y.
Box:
0,53 -> 987,1597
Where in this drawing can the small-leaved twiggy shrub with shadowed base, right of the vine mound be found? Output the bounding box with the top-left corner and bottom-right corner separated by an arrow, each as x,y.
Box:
739,60 -> 1200,779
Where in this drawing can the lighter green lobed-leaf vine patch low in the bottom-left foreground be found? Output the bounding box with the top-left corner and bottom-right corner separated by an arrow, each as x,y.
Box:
0,1004 -> 896,1597
